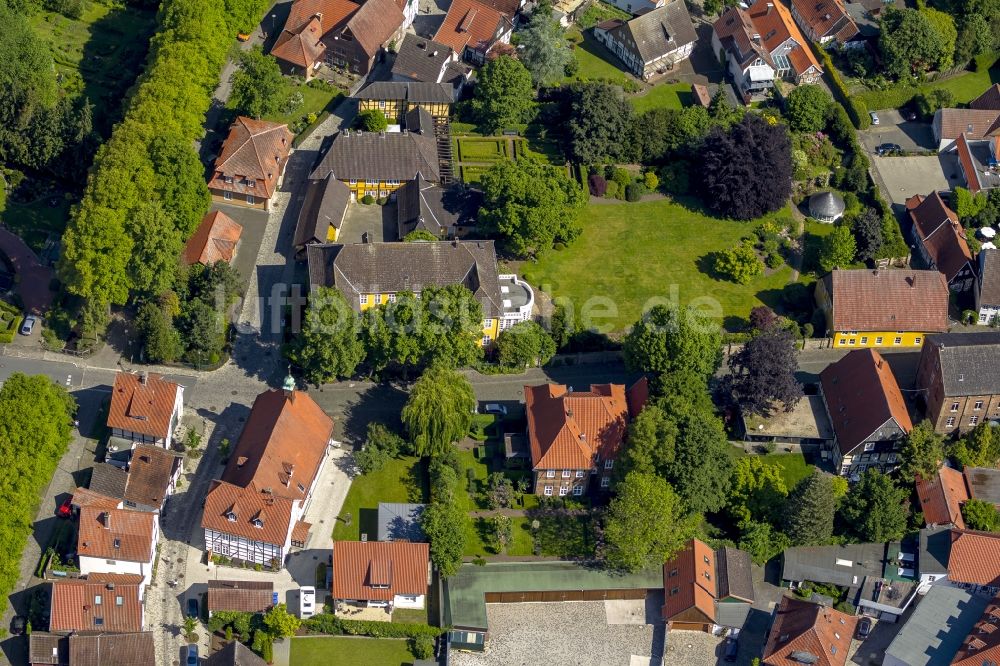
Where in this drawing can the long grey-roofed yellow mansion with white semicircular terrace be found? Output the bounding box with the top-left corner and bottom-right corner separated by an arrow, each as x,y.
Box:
306,240 -> 534,347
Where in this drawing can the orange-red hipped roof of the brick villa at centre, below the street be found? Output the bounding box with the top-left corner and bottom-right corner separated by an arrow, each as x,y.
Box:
524,384 -> 641,470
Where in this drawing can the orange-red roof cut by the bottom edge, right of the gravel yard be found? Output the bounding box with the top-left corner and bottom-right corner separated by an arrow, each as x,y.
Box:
764,597 -> 858,666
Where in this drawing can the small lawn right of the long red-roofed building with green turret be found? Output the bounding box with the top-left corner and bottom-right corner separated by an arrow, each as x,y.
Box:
333,457 -> 427,541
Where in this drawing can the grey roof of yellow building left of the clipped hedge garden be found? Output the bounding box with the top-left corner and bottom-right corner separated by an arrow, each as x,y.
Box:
309,130 -> 440,182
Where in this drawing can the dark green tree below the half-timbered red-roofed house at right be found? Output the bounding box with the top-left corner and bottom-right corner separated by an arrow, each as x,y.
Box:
840,469 -> 910,543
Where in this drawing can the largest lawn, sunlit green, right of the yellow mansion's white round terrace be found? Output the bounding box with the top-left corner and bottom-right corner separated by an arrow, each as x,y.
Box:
521,199 -> 791,333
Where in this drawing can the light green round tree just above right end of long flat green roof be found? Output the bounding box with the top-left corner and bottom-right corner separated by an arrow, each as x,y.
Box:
604,472 -> 691,571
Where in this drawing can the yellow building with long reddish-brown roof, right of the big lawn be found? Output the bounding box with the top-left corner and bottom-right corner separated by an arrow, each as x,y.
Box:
816,269 -> 948,349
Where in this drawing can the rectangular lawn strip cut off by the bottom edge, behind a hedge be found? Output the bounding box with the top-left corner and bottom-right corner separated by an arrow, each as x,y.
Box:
289,636 -> 414,666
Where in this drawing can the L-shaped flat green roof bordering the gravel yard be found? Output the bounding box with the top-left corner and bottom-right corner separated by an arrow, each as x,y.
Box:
442,561 -> 663,631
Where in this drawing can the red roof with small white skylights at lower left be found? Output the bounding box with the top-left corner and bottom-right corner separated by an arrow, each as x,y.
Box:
49,574 -> 142,632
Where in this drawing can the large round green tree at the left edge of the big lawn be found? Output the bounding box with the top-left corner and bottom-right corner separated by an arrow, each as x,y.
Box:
479,158 -> 586,257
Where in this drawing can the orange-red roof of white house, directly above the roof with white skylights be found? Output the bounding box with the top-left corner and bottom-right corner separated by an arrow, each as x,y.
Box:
76,506 -> 156,562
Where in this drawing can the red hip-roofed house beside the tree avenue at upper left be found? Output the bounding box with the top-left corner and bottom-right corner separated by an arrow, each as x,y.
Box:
208,116 -> 295,199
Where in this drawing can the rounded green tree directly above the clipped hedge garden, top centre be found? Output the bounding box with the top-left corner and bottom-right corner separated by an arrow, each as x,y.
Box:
471,56 -> 535,134
